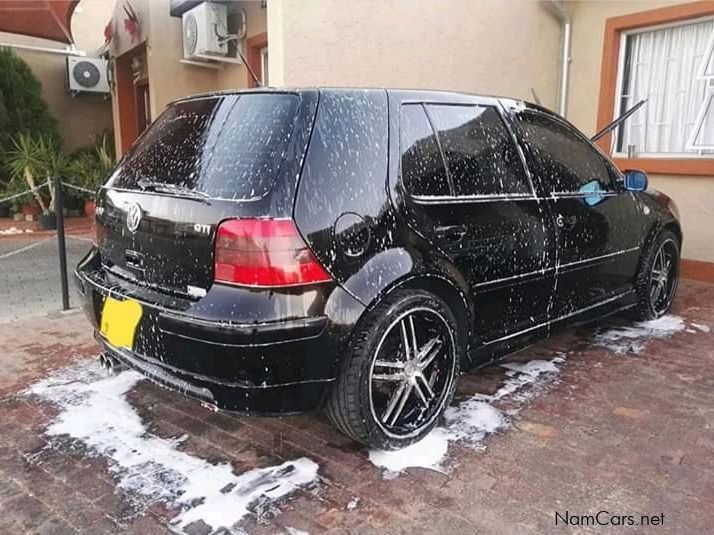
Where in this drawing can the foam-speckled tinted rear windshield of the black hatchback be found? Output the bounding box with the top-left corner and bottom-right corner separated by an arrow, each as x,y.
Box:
108,94 -> 300,200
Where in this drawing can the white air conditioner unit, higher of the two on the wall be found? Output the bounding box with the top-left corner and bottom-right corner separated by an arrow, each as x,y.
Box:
182,2 -> 228,60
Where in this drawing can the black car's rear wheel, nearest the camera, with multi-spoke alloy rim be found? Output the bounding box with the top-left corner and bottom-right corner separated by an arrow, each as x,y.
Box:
326,290 -> 458,450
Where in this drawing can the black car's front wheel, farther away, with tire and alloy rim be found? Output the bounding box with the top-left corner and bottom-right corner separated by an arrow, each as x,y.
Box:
633,230 -> 680,321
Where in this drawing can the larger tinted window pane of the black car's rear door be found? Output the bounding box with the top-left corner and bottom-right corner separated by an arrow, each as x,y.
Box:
427,105 -> 531,196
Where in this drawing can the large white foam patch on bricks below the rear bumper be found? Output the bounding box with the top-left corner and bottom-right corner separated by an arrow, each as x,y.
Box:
28,361 -> 318,531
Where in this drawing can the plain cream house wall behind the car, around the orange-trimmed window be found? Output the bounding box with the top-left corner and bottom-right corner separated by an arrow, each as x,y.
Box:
268,0 -> 714,262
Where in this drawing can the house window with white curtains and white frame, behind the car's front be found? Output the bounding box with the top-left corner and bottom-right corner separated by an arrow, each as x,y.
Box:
615,18 -> 714,158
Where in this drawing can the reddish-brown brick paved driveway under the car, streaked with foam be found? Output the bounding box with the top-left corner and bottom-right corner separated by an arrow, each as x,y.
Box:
0,282 -> 714,534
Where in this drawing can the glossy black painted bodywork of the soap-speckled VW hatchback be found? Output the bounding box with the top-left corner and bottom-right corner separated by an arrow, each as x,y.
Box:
76,90 -> 681,413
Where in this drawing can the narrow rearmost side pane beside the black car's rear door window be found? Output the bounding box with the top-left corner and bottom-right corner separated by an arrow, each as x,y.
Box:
400,104 -> 451,196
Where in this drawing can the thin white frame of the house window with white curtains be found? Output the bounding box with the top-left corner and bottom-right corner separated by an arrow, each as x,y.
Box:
610,15 -> 714,160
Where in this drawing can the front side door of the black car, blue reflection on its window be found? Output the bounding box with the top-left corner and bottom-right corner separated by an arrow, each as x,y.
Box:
514,109 -> 641,318
